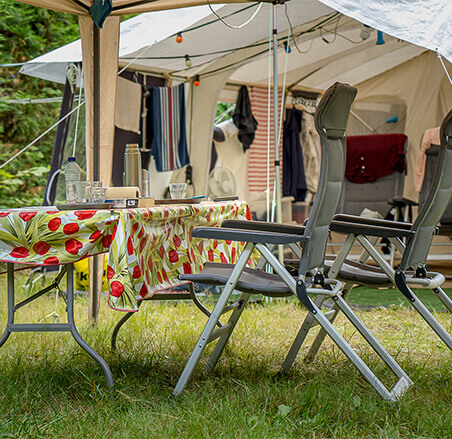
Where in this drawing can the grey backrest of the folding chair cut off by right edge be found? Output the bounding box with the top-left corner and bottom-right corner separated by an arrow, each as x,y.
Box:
400,110 -> 452,270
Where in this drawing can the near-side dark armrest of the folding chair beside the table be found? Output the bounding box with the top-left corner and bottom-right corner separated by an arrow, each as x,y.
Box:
192,227 -> 307,244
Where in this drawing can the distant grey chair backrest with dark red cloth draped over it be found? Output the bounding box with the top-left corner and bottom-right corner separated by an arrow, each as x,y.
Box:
337,134 -> 408,217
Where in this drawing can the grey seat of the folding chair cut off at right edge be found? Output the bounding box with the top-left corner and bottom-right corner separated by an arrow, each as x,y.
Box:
324,255 -> 393,287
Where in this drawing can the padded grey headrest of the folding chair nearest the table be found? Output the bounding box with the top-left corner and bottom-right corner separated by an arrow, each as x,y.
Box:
315,82 -> 357,139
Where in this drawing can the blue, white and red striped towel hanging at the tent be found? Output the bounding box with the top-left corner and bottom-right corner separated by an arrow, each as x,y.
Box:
150,84 -> 189,172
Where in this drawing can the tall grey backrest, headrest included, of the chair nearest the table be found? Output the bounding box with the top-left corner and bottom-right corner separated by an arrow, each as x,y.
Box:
300,83 -> 357,274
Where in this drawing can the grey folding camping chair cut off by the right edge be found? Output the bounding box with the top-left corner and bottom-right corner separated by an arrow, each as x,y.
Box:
292,110 -> 452,359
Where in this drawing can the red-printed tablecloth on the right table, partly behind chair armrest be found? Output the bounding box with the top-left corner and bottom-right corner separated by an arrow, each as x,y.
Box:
107,200 -> 251,311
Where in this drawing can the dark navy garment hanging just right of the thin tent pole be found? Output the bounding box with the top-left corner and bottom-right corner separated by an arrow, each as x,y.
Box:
283,108 -> 307,201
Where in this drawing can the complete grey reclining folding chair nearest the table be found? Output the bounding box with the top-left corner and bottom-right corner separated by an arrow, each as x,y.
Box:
173,83 -> 412,401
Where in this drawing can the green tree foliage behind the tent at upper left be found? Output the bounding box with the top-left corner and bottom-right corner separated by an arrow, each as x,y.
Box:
0,0 -> 79,207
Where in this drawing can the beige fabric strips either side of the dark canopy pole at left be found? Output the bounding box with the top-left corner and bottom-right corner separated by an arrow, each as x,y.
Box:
79,16 -> 119,186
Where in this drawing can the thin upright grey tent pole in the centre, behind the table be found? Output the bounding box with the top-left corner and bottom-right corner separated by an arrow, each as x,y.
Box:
272,2 -> 281,223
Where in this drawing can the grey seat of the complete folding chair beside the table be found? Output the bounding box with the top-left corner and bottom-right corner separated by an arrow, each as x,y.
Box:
179,262 -> 293,297
